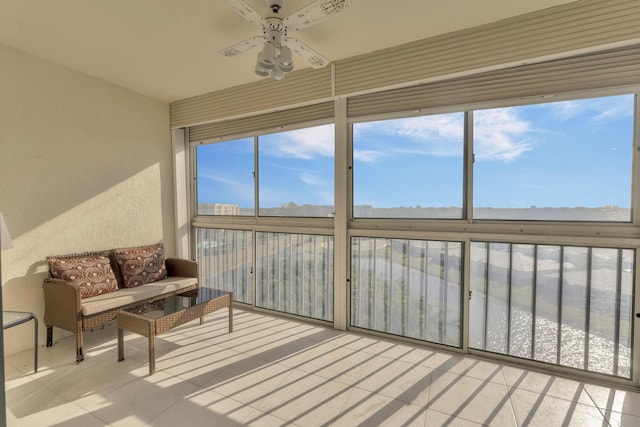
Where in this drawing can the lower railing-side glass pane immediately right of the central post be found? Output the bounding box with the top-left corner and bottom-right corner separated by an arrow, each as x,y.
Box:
351,237 -> 462,347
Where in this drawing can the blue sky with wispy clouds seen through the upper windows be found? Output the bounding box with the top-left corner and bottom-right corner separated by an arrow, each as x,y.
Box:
198,95 -> 633,212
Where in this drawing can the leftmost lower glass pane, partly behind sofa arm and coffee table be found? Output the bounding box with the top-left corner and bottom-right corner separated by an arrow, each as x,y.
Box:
196,228 -> 253,304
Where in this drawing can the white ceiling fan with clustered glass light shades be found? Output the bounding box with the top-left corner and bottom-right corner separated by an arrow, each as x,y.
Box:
219,0 -> 349,80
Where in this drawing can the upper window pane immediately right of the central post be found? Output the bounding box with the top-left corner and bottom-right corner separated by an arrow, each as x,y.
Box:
353,113 -> 464,218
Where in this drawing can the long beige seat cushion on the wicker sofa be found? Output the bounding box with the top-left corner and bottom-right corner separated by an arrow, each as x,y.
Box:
82,277 -> 198,316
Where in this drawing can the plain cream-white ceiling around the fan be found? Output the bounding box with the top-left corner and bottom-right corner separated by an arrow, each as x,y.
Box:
0,0 -> 574,102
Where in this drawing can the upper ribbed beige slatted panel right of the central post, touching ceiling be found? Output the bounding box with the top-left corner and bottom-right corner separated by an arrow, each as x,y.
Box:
335,0 -> 640,96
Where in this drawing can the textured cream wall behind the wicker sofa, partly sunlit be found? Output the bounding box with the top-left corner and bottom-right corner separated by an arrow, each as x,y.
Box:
0,45 -> 175,358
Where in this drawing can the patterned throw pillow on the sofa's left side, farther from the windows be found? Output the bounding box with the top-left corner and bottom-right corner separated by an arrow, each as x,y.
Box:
47,255 -> 118,298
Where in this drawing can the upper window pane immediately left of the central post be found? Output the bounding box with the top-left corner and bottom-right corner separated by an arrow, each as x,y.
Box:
258,124 -> 335,217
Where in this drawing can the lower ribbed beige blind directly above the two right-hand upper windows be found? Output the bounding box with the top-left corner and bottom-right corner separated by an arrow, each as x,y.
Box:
347,45 -> 640,117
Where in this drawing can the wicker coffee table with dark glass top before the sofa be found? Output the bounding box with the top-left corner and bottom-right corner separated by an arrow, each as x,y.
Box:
117,288 -> 233,375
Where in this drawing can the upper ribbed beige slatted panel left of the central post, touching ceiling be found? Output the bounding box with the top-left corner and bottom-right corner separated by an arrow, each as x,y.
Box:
170,67 -> 331,128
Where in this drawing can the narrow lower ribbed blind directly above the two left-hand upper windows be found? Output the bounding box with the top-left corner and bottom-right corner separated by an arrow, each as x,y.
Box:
189,102 -> 334,142
